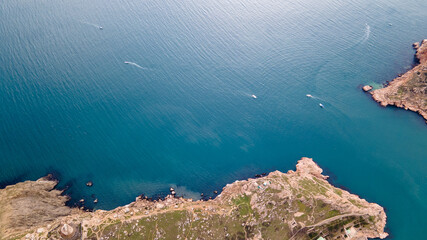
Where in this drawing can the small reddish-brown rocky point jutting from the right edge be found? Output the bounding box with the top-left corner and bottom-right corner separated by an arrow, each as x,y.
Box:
371,39 -> 427,121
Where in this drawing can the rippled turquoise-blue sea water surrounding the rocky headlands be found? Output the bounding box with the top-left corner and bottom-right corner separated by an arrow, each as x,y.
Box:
0,0 -> 427,239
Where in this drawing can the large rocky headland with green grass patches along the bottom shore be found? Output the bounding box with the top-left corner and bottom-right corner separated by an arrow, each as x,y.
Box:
0,158 -> 388,240
